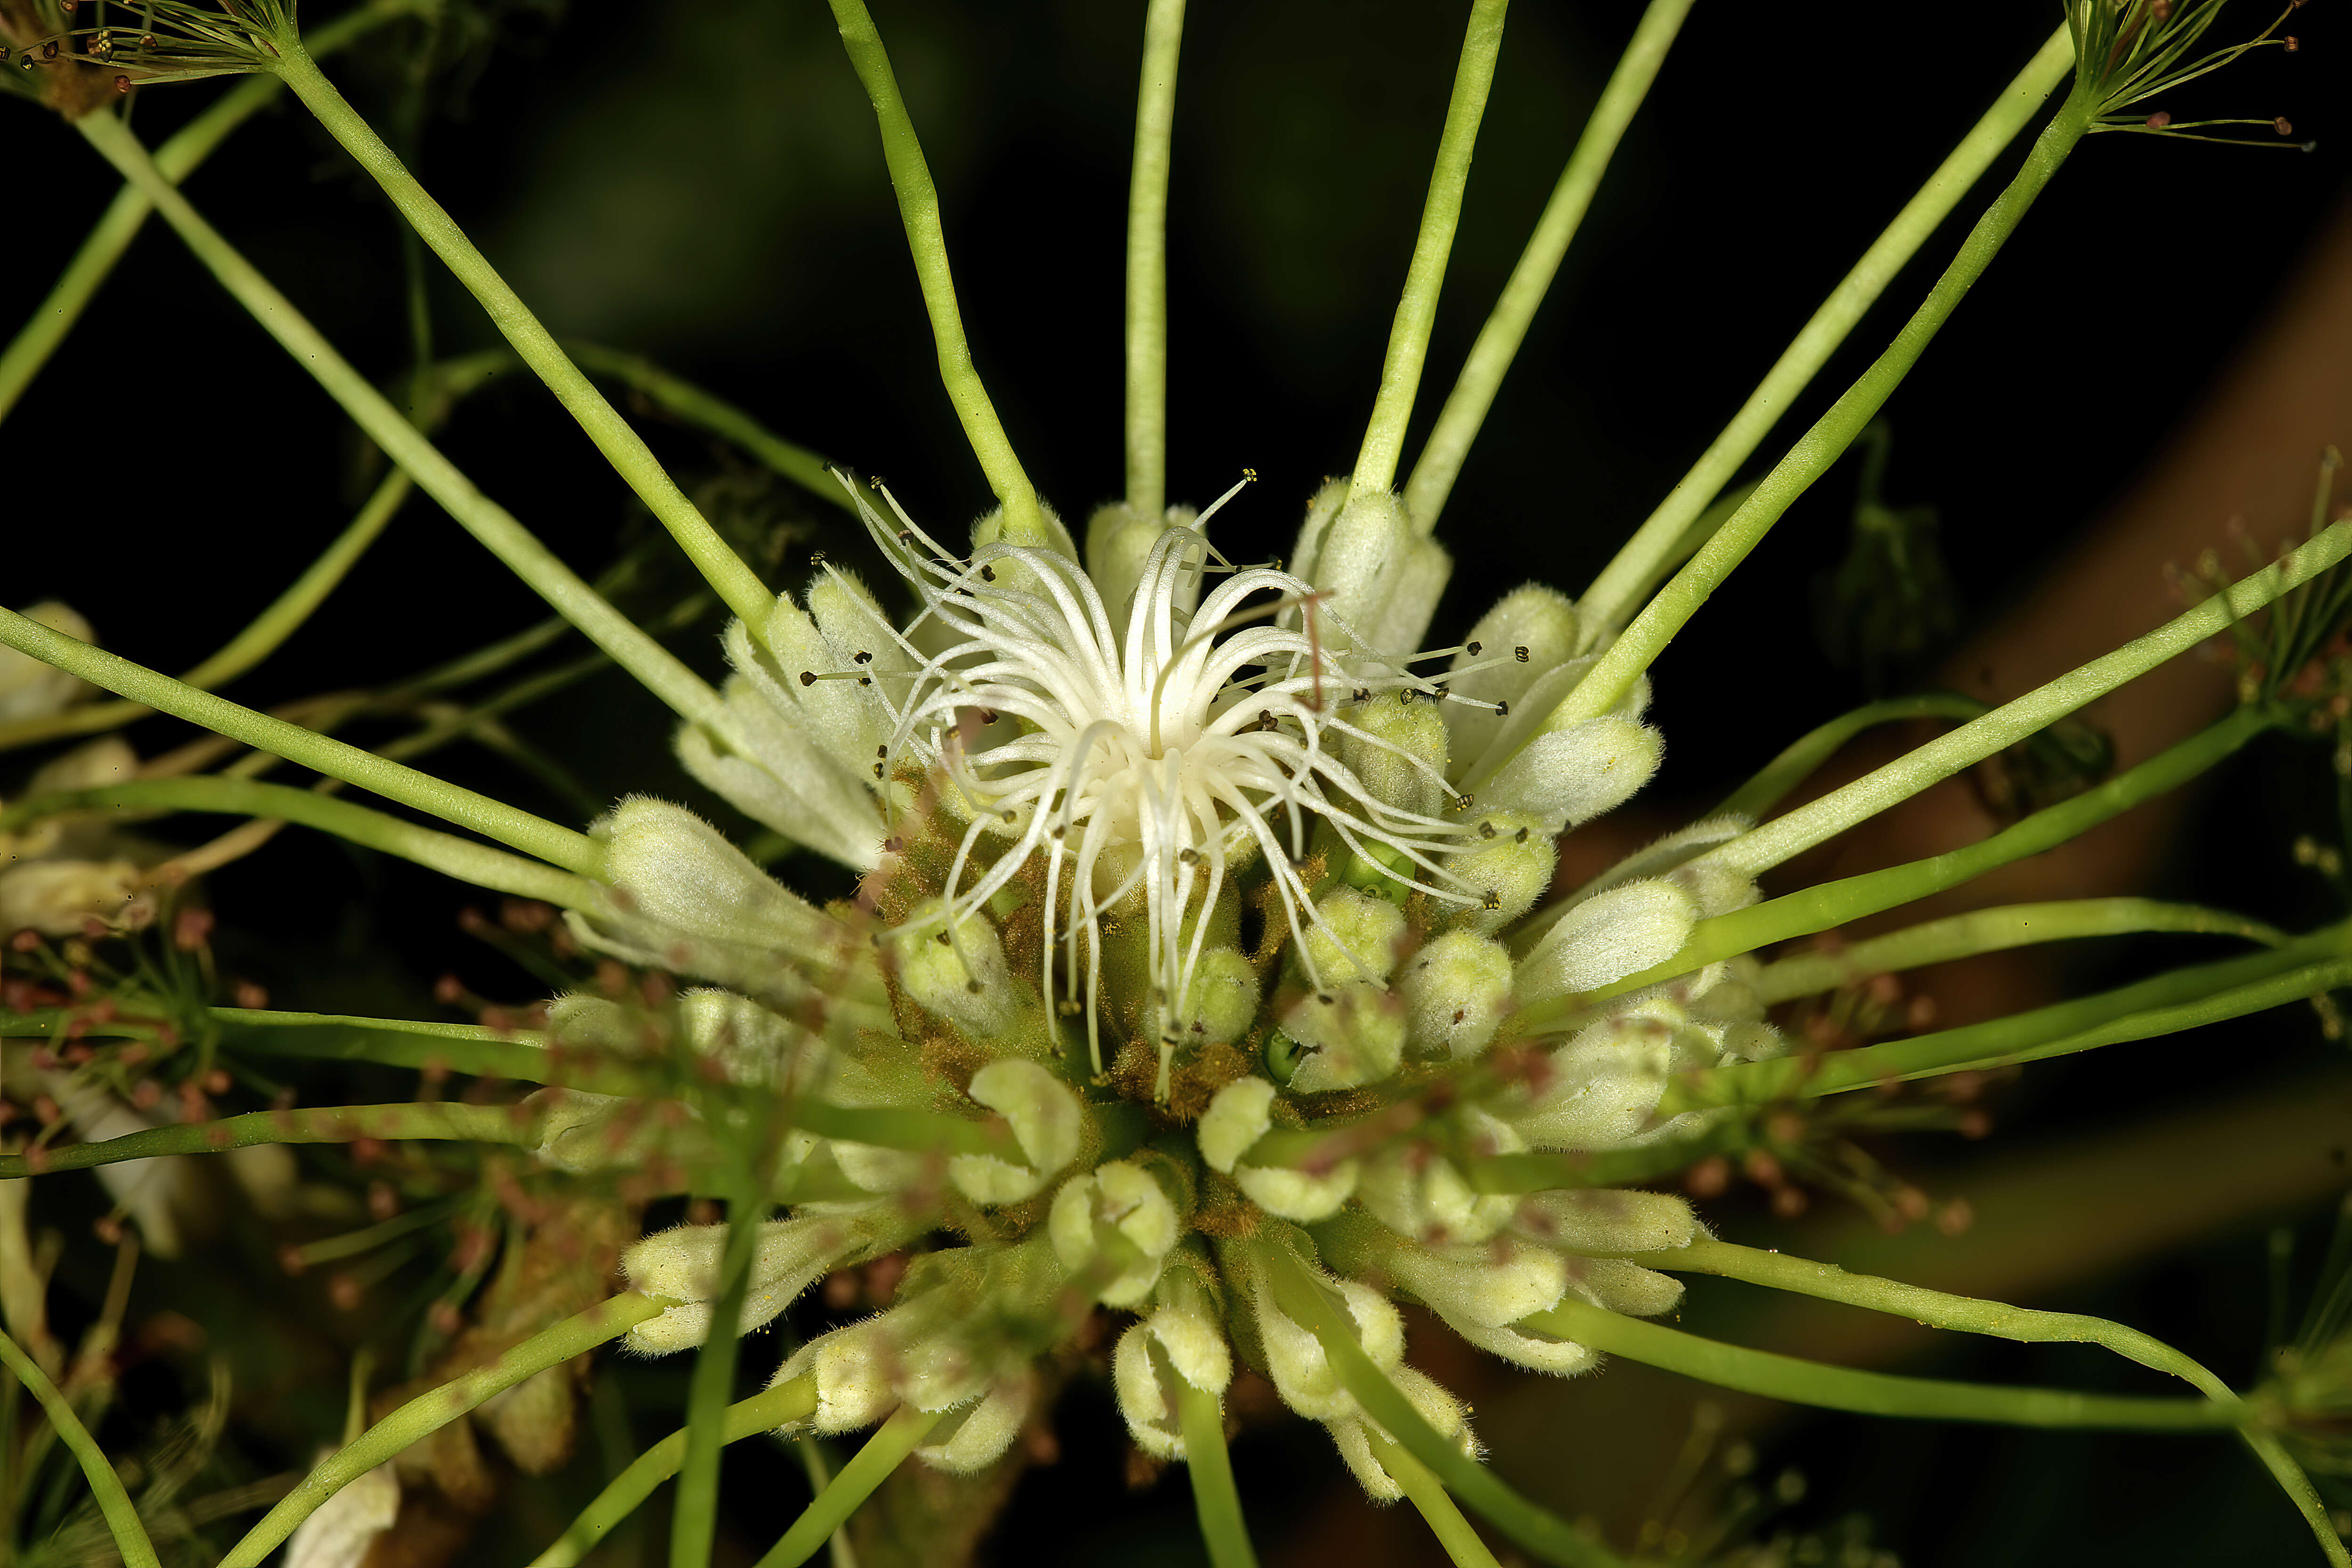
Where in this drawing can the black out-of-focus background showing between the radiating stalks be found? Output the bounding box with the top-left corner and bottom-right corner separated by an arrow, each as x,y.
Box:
0,0 -> 2352,1566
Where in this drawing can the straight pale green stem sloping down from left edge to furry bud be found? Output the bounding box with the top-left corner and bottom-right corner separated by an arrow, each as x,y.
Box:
0,609 -> 604,874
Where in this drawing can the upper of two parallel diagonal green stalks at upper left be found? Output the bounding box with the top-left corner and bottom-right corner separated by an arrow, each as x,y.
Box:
260,31 -> 776,632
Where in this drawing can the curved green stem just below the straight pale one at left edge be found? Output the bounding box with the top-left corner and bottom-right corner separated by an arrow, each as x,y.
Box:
0,776 -> 602,910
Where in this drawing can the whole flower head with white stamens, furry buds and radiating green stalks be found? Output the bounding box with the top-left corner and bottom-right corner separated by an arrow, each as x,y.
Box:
0,0 -> 2352,1568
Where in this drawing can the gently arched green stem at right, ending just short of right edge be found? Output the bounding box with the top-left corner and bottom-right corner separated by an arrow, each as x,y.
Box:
1757,898 -> 2286,1006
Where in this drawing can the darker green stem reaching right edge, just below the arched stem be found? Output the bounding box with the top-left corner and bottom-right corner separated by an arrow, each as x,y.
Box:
1658,924 -> 2352,1114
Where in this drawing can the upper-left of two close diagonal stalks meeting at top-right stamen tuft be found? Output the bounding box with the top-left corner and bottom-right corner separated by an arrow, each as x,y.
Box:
1578,26 -> 2074,628
